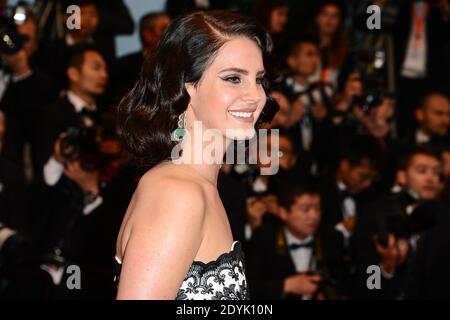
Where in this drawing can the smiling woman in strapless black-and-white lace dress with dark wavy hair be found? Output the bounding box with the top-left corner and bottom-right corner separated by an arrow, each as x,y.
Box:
116,11 -> 277,299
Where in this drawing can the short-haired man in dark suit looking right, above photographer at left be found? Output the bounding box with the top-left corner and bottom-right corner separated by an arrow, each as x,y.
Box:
37,45 -> 108,179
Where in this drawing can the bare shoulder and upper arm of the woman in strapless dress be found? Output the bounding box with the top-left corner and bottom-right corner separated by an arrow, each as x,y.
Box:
117,166 -> 205,299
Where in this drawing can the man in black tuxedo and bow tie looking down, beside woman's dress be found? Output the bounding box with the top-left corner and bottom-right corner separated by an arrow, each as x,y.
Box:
247,182 -> 343,299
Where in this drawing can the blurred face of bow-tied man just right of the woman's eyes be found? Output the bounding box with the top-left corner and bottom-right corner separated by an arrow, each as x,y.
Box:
288,42 -> 320,77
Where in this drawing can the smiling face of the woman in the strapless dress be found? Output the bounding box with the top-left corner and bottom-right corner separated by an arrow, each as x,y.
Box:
186,37 -> 266,140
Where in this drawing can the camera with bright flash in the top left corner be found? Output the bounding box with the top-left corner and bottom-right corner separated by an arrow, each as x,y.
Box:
0,4 -> 28,55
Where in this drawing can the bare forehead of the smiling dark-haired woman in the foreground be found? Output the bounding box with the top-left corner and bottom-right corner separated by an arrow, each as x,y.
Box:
209,37 -> 264,73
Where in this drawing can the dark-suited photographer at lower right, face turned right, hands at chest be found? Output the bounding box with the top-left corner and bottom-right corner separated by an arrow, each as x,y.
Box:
353,148 -> 442,299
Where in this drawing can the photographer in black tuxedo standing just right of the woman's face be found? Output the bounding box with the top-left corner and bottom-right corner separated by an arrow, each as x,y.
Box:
277,36 -> 336,176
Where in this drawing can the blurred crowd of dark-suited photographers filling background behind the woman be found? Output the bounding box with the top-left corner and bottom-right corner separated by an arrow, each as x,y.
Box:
0,0 -> 450,300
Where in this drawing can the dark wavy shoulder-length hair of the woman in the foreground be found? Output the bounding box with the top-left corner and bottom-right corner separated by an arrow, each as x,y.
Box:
117,11 -> 278,169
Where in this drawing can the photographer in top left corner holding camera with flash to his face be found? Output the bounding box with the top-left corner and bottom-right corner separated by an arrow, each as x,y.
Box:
0,6 -> 56,175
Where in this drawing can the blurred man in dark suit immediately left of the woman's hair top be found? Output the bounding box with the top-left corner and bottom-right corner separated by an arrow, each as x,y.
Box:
112,12 -> 170,99
